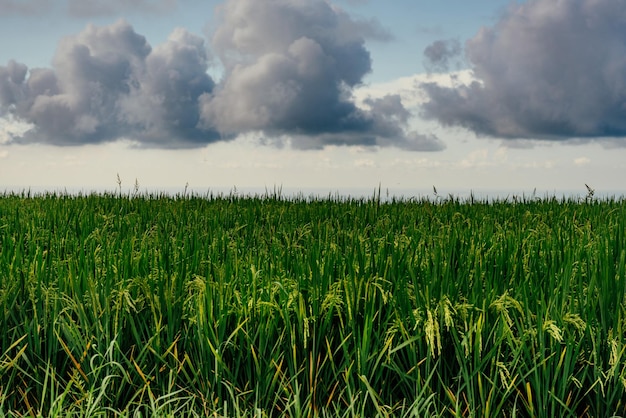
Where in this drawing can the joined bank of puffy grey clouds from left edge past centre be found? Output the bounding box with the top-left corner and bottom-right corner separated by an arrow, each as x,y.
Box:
0,0 -> 443,151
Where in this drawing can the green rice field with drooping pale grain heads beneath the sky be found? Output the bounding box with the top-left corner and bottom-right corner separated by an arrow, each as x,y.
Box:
0,194 -> 626,417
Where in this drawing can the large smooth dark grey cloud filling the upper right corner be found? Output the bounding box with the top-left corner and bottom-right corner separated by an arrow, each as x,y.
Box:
423,0 -> 626,140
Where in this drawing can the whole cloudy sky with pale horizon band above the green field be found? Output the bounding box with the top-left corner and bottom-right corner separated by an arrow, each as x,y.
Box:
0,0 -> 626,196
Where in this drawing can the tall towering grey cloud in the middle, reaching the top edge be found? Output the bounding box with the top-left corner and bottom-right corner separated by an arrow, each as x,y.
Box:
201,0 -> 434,148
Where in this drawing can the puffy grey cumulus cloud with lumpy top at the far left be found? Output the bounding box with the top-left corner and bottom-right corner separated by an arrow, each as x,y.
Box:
0,21 -> 218,147
